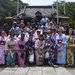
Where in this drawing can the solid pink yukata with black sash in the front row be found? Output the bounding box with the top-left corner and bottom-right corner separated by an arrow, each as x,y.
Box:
15,39 -> 26,67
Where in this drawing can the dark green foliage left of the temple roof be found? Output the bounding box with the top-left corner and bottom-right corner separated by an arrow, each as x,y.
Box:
0,0 -> 27,19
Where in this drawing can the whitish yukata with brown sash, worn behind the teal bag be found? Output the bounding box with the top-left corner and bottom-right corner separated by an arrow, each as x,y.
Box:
5,39 -> 16,64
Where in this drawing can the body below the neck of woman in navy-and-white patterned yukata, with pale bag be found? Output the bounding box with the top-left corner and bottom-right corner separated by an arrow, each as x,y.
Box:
44,39 -> 55,66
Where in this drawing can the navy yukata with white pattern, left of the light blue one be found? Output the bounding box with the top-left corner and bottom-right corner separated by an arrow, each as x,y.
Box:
45,38 -> 56,65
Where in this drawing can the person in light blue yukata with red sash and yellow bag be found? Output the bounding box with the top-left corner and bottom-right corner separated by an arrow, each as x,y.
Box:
56,28 -> 67,65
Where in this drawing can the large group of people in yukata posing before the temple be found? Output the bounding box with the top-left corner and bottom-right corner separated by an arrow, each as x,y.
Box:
0,16 -> 74,67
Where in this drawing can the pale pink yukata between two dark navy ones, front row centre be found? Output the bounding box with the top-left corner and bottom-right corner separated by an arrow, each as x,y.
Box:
35,39 -> 45,65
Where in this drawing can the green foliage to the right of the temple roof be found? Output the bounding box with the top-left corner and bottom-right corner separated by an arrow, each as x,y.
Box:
53,2 -> 75,27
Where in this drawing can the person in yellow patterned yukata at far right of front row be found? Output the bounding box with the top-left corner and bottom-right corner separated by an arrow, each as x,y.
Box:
67,29 -> 74,66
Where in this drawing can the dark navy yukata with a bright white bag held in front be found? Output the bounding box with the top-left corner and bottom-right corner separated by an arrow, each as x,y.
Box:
26,40 -> 35,65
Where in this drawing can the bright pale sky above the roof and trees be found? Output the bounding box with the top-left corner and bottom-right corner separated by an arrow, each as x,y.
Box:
21,0 -> 75,5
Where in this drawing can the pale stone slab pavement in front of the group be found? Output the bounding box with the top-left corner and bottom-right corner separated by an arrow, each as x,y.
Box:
0,67 -> 75,75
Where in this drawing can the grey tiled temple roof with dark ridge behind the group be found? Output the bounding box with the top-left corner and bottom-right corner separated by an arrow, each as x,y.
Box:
19,6 -> 56,17
